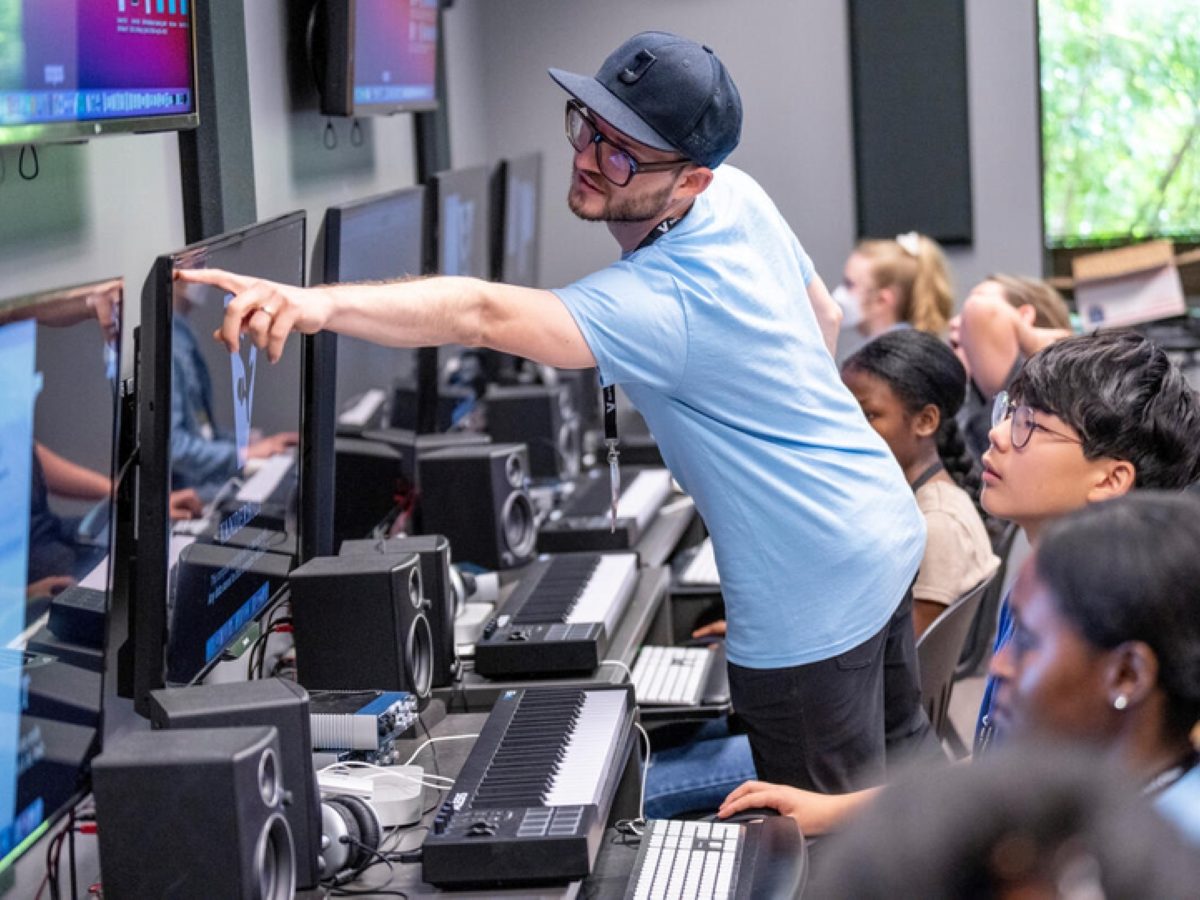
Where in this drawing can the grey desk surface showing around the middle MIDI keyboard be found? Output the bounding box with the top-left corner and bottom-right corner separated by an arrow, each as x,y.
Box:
433,566 -> 670,713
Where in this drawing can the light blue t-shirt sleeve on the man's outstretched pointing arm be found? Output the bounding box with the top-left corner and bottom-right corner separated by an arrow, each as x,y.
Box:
554,260 -> 688,391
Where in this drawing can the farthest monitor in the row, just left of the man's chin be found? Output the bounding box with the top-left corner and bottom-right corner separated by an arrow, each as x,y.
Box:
492,154 -> 541,288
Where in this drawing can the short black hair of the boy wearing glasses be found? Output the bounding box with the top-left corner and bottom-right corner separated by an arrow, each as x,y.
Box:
1008,331 -> 1200,487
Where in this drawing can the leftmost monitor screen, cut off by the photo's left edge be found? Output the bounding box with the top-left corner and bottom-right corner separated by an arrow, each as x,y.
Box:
0,280 -> 122,871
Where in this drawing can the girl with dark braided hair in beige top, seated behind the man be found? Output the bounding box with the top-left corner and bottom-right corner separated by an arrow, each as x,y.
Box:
841,329 -> 1000,636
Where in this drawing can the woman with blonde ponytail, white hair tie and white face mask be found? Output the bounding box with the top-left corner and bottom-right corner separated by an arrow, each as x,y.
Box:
832,232 -> 954,337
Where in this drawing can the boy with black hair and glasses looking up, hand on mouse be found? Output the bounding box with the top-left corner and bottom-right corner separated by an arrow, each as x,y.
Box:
720,331 -> 1200,834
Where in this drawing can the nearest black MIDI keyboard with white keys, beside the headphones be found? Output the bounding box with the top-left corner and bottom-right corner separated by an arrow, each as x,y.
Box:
421,685 -> 636,887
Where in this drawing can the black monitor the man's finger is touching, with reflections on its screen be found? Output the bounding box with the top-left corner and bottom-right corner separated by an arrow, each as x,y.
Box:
131,212 -> 319,714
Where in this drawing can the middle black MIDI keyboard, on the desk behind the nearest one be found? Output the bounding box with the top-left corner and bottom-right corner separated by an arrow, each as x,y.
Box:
475,553 -> 637,678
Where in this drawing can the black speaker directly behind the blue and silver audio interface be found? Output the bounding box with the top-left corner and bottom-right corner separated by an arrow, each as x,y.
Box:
290,553 -> 433,697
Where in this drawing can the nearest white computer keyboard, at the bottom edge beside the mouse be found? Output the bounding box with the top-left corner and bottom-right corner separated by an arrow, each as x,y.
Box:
625,818 -> 743,900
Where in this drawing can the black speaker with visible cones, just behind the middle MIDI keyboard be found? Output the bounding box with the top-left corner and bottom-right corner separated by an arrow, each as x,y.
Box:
421,444 -> 538,569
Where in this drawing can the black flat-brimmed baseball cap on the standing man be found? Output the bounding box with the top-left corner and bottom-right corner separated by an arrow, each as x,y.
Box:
550,31 -> 742,168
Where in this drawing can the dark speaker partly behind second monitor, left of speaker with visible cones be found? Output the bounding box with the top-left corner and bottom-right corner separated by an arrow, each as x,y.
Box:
334,437 -> 412,547
